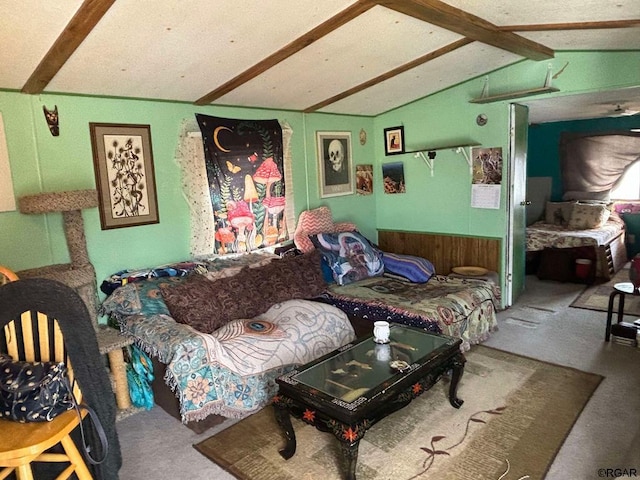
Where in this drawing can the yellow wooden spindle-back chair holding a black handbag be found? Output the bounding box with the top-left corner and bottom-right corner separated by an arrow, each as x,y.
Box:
0,281 -> 93,480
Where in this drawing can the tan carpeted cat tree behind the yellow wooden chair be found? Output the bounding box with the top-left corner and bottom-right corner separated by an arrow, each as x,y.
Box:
16,190 -> 132,409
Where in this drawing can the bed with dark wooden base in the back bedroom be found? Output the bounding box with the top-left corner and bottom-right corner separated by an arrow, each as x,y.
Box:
526,202 -> 627,281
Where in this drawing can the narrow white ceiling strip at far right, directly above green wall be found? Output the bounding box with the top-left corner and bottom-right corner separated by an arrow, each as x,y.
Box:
520,27 -> 640,50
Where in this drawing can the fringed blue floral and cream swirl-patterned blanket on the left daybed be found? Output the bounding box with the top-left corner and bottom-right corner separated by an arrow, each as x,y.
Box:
120,300 -> 355,422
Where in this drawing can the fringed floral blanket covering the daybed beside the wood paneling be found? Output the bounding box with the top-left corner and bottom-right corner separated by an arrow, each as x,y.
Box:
327,275 -> 500,350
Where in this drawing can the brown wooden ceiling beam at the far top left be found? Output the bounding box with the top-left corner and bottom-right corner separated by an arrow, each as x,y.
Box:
21,0 -> 115,94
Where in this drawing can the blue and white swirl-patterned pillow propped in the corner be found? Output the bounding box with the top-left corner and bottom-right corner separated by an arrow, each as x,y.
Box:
309,232 -> 384,285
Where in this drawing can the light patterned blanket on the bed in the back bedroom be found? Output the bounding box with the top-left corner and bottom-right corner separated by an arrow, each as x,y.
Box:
527,217 -> 624,252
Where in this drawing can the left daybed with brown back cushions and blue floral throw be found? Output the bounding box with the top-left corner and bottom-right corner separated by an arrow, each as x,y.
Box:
100,249 -> 355,431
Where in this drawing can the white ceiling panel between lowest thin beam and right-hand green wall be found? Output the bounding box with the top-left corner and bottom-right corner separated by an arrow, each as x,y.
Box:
321,42 -> 521,115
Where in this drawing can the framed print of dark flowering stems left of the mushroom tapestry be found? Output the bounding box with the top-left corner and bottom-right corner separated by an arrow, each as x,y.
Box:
89,123 -> 160,230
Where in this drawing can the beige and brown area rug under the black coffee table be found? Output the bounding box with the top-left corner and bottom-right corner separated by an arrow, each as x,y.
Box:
194,346 -> 602,480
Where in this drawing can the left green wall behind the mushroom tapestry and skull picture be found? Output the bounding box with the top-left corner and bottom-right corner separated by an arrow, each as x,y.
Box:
0,92 -> 376,292
